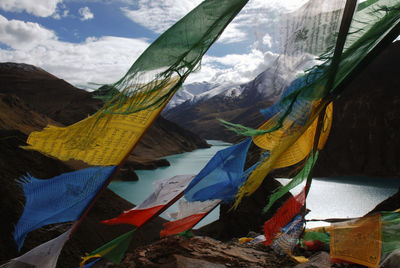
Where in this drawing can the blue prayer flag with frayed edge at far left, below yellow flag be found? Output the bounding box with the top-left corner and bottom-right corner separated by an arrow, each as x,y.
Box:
14,166 -> 115,249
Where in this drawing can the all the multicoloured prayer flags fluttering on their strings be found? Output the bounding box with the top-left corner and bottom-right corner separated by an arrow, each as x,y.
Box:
1,0 -> 400,268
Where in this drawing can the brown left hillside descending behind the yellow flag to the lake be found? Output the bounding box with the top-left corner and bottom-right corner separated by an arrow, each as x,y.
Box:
0,63 -> 209,169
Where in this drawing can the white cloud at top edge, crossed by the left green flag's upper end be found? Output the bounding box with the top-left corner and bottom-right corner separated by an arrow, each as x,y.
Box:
122,0 -> 308,44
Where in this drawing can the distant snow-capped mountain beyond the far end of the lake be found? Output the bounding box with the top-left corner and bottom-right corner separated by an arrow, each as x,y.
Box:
163,68 -> 286,142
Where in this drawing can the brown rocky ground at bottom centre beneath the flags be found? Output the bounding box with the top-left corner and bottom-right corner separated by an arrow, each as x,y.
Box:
123,237 -> 295,268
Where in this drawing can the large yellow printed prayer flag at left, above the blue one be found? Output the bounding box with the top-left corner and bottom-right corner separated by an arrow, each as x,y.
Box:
25,78 -> 178,166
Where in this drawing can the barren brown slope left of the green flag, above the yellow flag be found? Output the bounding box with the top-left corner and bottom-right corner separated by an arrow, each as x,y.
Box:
0,63 -> 102,125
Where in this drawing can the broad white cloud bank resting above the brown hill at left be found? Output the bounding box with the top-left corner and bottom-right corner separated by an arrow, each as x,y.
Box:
0,16 -> 149,86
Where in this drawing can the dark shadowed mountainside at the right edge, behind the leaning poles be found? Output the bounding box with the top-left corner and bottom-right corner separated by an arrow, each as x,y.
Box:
314,42 -> 400,177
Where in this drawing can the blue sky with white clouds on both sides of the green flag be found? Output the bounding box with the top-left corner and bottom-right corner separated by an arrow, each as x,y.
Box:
0,0 -> 306,88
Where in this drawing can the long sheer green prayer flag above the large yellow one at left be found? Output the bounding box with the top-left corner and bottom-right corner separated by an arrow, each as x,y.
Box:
100,0 -> 248,114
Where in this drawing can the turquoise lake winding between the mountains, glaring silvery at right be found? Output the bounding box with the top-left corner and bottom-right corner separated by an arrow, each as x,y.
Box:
108,141 -> 400,227
